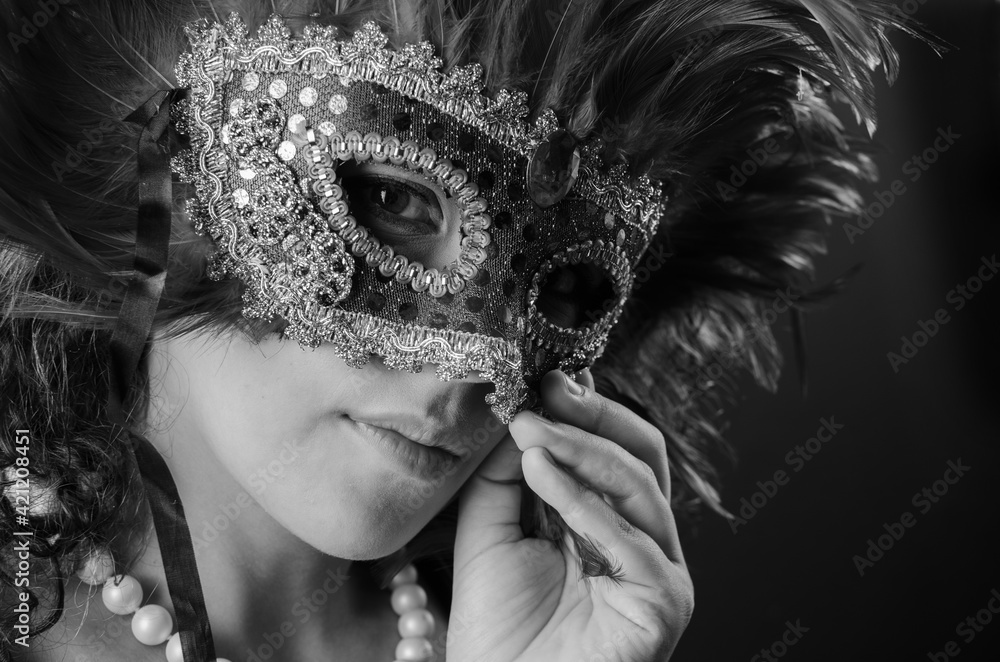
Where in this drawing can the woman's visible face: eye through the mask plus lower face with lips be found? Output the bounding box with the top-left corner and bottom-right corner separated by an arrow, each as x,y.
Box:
150,165 -> 506,559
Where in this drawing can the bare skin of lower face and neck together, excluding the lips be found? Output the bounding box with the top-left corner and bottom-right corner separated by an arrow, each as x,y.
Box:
141,330 -> 502,660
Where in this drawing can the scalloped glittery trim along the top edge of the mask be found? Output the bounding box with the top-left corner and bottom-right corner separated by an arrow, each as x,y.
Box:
179,13 -> 663,237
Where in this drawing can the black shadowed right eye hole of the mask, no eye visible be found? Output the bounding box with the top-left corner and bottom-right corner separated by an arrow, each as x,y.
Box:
535,262 -> 618,329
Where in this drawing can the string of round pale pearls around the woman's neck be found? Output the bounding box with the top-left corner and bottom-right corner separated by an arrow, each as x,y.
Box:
76,550 -> 434,662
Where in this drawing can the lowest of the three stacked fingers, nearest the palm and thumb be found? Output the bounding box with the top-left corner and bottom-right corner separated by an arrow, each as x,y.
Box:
521,446 -> 672,587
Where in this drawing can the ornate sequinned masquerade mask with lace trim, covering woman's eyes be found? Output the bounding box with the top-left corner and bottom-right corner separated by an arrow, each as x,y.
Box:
174,14 -> 662,423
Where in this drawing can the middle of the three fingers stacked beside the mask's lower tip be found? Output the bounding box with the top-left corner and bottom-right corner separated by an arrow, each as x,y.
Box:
510,411 -> 684,564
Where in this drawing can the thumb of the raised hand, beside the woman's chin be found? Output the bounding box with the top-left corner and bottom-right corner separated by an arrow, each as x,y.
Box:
455,434 -> 524,569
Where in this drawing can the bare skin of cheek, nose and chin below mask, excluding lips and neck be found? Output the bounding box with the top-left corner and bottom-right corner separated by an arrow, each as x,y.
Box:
144,326 -> 499,559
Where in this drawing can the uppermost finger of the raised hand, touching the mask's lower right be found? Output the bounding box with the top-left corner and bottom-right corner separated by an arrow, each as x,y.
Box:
540,370 -> 670,499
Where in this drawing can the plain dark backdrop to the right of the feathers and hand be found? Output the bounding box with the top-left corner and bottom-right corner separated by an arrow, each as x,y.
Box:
675,5 -> 1000,662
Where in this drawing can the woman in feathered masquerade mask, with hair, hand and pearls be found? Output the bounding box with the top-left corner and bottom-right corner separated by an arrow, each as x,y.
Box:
0,0 -> 916,662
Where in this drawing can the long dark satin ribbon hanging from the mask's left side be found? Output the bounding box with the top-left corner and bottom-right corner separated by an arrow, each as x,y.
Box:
108,89 -> 215,662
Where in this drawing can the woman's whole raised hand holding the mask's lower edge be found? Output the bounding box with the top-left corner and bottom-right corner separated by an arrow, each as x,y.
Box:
447,371 -> 694,662
